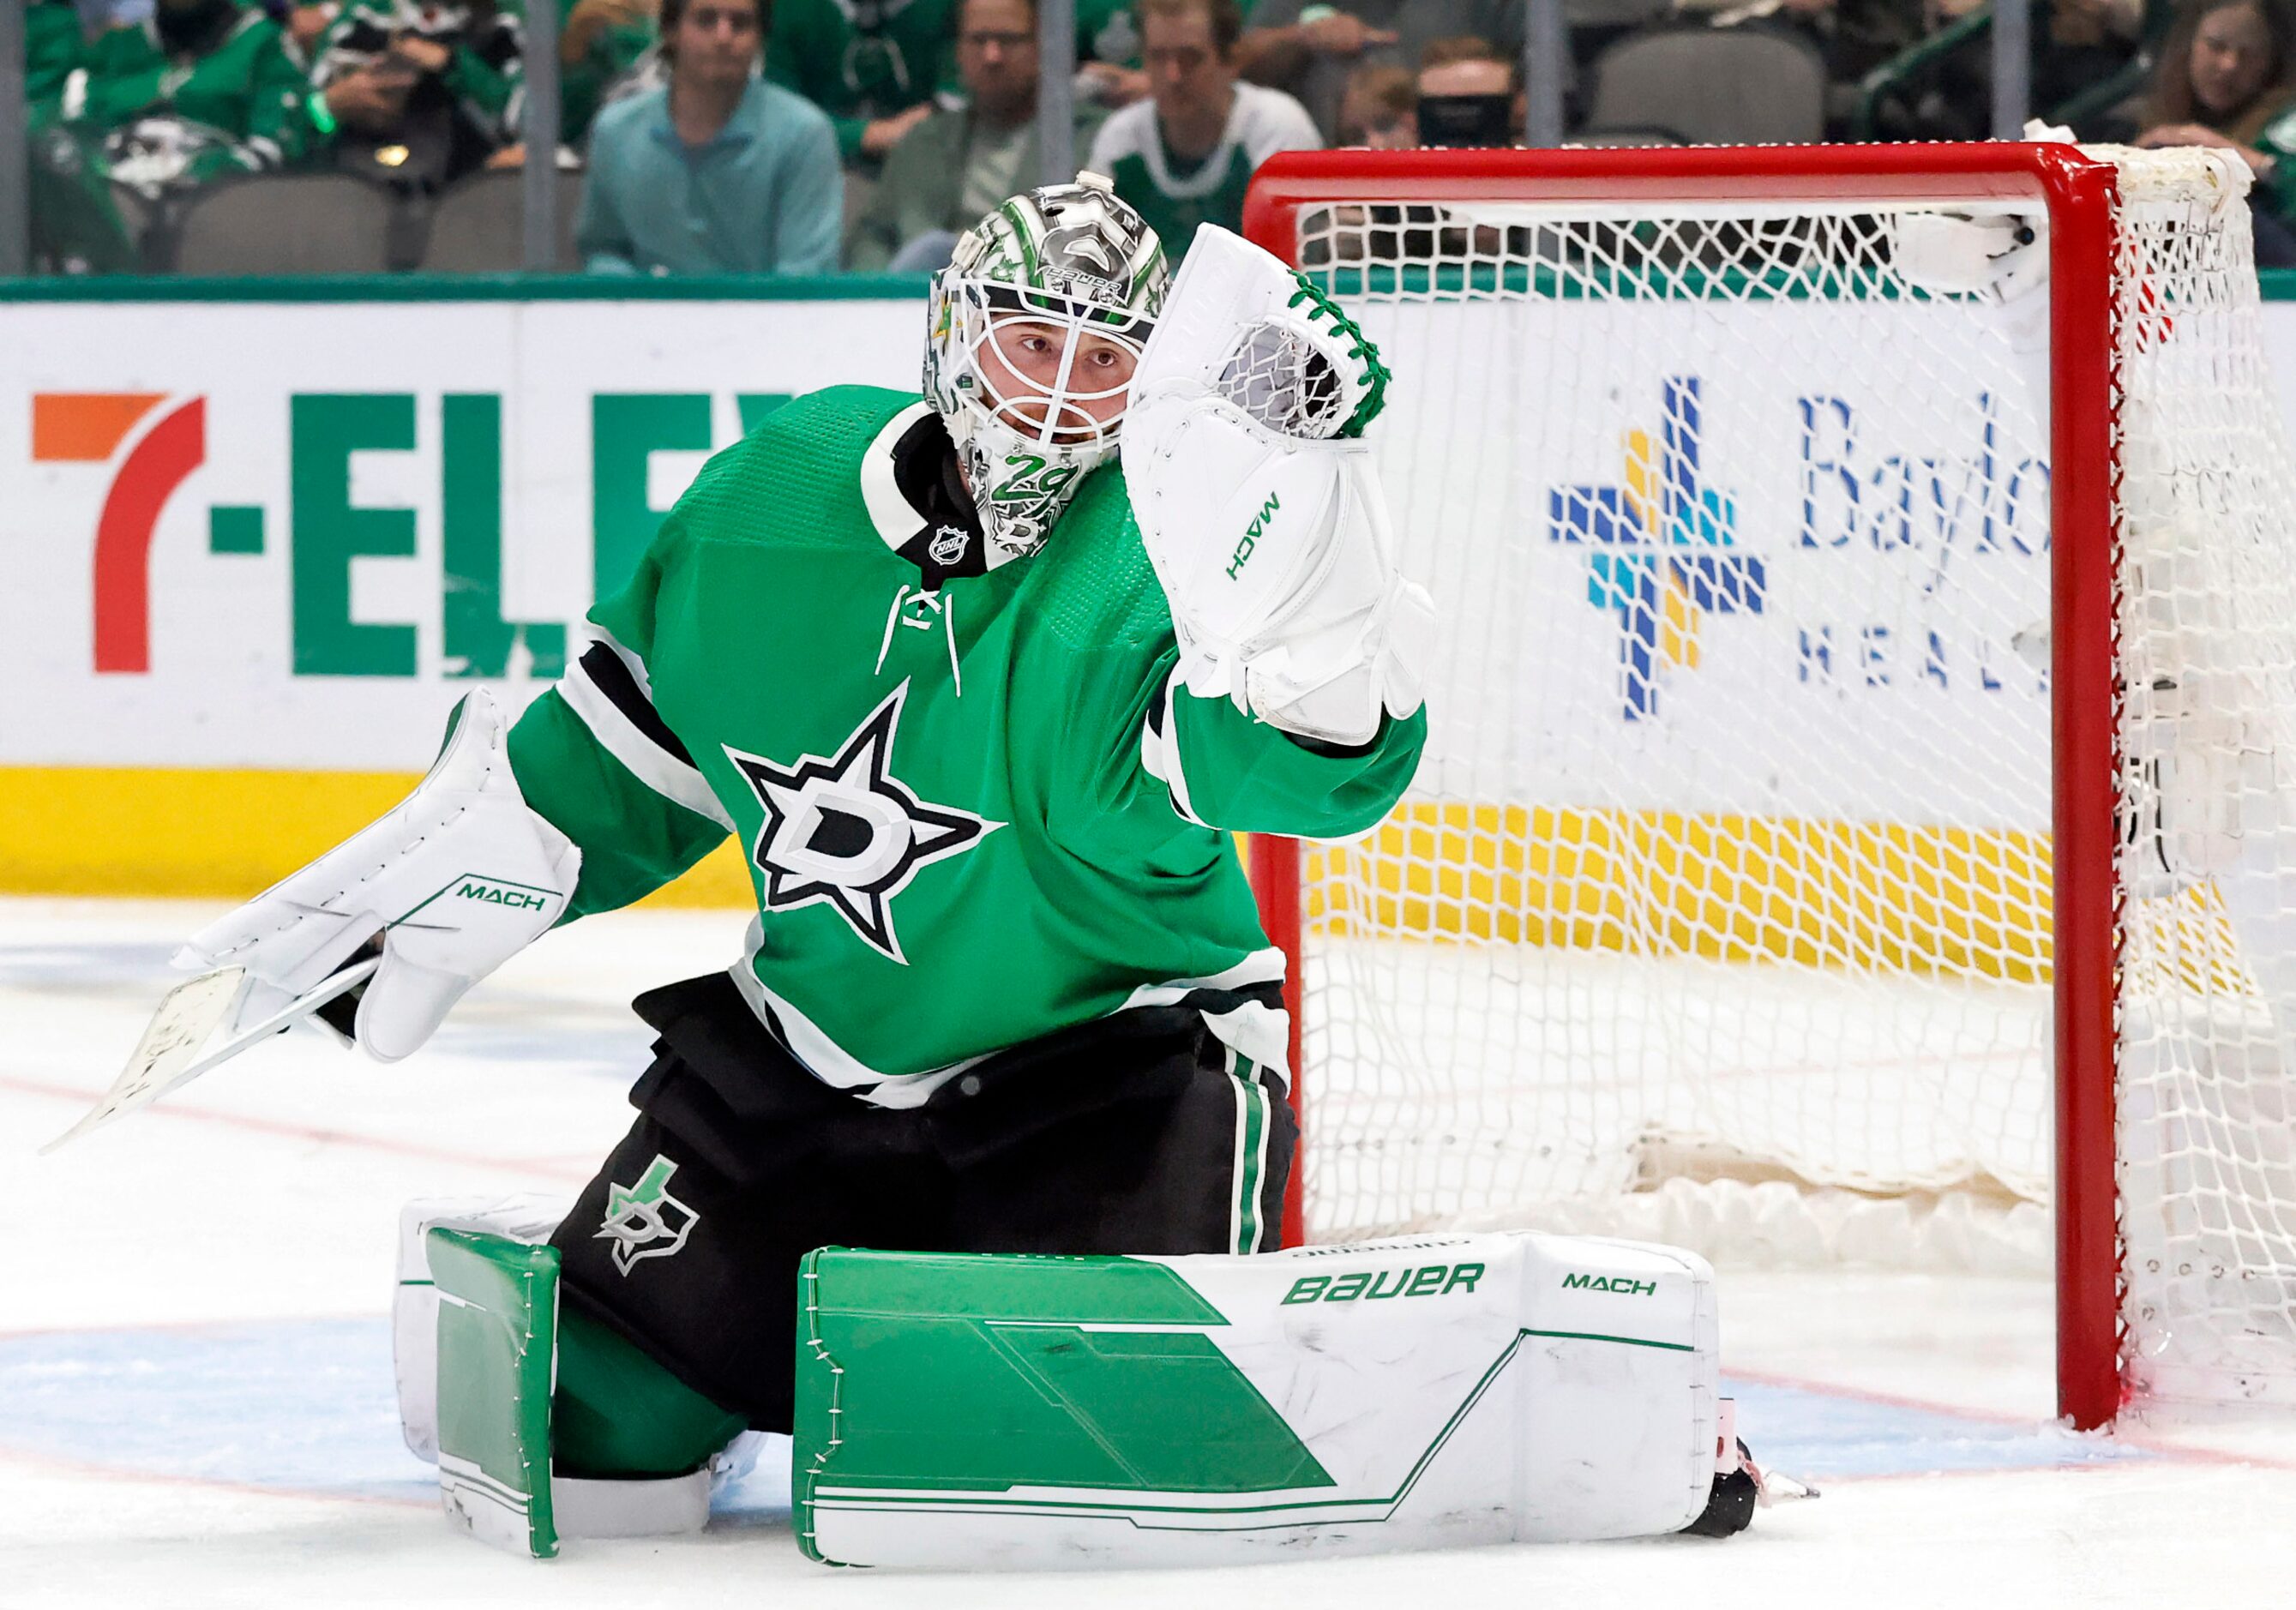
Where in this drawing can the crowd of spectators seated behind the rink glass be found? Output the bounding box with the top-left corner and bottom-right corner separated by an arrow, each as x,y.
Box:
13,0 -> 2296,275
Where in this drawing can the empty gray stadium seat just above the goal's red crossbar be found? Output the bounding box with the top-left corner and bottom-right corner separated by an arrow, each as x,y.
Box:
1586,27 -> 1825,145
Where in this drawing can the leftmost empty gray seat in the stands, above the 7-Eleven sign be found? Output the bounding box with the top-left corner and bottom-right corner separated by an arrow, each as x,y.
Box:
172,172 -> 393,273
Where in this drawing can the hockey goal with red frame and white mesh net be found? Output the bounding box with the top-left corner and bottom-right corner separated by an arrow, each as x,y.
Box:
1252,147 -> 2296,1421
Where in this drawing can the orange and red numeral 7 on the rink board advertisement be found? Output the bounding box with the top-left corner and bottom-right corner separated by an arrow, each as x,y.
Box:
32,390 -> 207,673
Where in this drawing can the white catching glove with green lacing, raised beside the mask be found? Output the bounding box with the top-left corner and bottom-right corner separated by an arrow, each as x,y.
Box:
1123,225 -> 1435,744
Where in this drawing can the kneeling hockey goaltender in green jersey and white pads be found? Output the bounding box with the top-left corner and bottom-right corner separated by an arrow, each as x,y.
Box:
121,175 -> 1757,1564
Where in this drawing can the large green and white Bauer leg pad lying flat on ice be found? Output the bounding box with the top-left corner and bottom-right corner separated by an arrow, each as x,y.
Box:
792,1234 -> 1722,1569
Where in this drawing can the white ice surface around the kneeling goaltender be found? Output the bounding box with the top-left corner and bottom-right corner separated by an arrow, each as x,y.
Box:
13,900 -> 2296,1610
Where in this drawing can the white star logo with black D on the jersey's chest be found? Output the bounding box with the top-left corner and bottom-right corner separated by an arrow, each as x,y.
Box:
725,682 -> 1003,964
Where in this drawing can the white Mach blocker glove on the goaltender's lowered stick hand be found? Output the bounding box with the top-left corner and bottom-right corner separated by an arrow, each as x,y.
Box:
175,689 -> 581,1061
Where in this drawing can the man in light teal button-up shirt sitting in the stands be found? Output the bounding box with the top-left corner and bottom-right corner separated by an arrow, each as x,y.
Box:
576,0 -> 845,273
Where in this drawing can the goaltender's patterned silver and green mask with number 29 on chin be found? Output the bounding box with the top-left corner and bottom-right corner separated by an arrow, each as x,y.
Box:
925,175 -> 1169,565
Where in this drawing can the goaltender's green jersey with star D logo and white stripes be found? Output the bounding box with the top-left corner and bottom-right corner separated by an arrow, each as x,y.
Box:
510,386 -> 1426,1107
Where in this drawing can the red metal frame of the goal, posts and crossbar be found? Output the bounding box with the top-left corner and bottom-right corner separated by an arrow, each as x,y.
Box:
1244,142 -> 2124,1428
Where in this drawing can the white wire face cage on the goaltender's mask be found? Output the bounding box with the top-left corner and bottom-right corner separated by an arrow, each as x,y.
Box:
951,280 -> 1152,461
